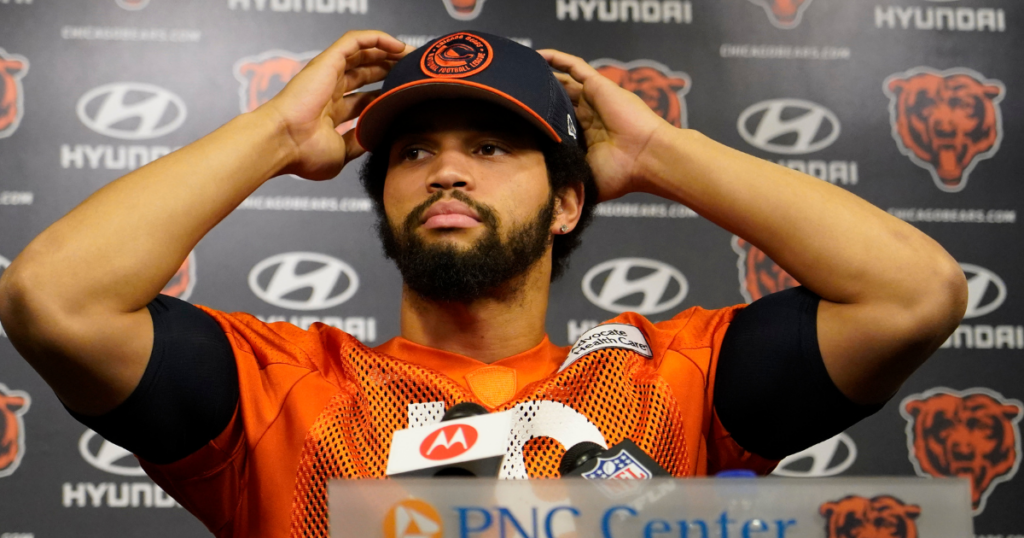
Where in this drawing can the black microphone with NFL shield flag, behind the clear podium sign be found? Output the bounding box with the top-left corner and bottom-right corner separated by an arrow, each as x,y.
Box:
558,439 -> 672,480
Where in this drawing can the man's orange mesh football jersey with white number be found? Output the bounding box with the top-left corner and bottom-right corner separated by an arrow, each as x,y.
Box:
141,305 -> 777,538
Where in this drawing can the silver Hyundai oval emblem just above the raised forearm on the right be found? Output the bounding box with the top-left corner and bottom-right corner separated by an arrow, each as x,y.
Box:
736,98 -> 840,155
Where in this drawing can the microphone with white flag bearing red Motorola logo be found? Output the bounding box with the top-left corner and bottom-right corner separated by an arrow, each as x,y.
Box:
386,402 -> 512,478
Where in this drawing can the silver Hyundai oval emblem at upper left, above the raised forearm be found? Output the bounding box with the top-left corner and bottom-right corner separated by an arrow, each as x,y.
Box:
75,82 -> 186,140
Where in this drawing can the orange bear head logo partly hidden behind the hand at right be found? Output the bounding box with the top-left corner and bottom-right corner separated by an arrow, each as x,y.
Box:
590,58 -> 693,128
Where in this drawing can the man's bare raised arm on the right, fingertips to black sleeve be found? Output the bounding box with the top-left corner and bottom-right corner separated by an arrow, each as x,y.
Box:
542,50 -> 967,404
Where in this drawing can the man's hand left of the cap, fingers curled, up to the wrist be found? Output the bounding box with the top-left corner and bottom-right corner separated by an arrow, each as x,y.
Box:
257,30 -> 412,179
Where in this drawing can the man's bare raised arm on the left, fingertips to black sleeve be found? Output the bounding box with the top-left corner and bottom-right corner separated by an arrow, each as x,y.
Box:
0,31 -> 404,415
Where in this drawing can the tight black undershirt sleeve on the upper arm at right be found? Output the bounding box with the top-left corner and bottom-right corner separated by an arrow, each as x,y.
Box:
714,287 -> 882,460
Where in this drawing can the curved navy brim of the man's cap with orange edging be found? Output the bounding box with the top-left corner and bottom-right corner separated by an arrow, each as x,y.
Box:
355,79 -> 562,152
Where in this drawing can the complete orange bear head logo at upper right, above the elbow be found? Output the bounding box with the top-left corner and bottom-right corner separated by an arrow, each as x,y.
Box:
883,68 -> 1007,193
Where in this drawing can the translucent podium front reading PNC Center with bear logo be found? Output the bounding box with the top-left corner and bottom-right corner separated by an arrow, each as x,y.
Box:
329,478 -> 973,538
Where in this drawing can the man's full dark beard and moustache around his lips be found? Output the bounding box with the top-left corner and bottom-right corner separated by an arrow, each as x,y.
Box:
377,191 -> 555,303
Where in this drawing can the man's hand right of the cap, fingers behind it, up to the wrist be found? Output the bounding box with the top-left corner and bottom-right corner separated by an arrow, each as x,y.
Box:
538,49 -> 676,202
